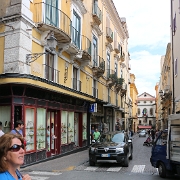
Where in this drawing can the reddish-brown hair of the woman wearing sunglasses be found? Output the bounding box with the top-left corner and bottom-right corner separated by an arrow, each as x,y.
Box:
0,133 -> 24,172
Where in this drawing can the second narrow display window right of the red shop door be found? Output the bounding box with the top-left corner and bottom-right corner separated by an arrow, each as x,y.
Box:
68,112 -> 74,144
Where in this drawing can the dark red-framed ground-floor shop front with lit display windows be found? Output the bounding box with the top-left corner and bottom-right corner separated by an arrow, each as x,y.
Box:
0,84 -> 90,165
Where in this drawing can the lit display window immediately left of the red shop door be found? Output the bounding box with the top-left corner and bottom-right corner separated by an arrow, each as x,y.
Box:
36,108 -> 46,150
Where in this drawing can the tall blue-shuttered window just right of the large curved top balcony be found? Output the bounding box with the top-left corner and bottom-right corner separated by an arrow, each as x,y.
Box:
72,10 -> 81,49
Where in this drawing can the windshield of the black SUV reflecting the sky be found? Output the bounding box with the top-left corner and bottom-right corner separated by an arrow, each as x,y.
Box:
100,133 -> 124,143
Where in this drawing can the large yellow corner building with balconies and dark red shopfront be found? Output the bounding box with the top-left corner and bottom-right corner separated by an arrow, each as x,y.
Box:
0,0 -> 129,164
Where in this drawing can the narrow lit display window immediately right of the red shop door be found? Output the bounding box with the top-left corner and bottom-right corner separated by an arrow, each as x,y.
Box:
61,111 -> 68,144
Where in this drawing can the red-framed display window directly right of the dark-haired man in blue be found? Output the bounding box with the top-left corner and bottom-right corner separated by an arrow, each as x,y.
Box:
25,108 -> 35,151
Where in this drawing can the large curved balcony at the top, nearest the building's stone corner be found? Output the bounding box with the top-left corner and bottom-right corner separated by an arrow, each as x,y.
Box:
34,2 -> 71,45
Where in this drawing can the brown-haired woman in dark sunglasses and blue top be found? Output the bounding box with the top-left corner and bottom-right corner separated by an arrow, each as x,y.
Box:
0,133 -> 31,180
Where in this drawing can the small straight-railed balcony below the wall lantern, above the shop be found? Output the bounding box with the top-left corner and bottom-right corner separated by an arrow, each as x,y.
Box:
43,64 -> 60,84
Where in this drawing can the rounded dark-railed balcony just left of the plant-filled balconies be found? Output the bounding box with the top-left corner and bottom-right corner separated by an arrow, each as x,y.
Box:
92,56 -> 105,78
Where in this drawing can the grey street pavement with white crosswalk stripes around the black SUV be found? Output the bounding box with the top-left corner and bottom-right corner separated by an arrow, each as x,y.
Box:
21,135 -> 178,180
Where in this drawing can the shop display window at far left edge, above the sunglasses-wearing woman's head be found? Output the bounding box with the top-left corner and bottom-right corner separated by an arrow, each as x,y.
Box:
0,106 -> 11,133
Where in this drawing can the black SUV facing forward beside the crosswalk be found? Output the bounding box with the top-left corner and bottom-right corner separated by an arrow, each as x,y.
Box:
89,131 -> 133,167
